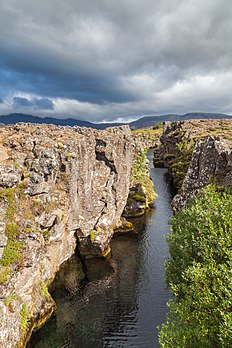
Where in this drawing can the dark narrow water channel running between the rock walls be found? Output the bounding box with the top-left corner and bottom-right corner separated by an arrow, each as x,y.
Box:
27,152 -> 172,348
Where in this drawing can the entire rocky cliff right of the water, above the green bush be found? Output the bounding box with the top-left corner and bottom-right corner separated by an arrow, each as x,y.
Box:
154,120 -> 232,210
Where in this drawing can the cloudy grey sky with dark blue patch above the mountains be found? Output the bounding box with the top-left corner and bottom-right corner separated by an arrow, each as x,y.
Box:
0,0 -> 232,122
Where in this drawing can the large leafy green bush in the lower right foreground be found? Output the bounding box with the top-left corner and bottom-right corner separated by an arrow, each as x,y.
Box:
159,185 -> 232,348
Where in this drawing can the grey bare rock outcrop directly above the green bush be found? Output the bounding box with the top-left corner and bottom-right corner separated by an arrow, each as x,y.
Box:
172,137 -> 232,210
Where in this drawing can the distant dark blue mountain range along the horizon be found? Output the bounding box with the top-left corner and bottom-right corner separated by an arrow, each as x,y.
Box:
0,112 -> 232,129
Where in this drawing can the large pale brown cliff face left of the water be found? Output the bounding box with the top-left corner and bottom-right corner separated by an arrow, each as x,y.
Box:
0,124 -> 135,348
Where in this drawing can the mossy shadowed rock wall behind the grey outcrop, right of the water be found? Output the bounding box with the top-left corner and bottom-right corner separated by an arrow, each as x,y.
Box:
154,120 -> 232,188
